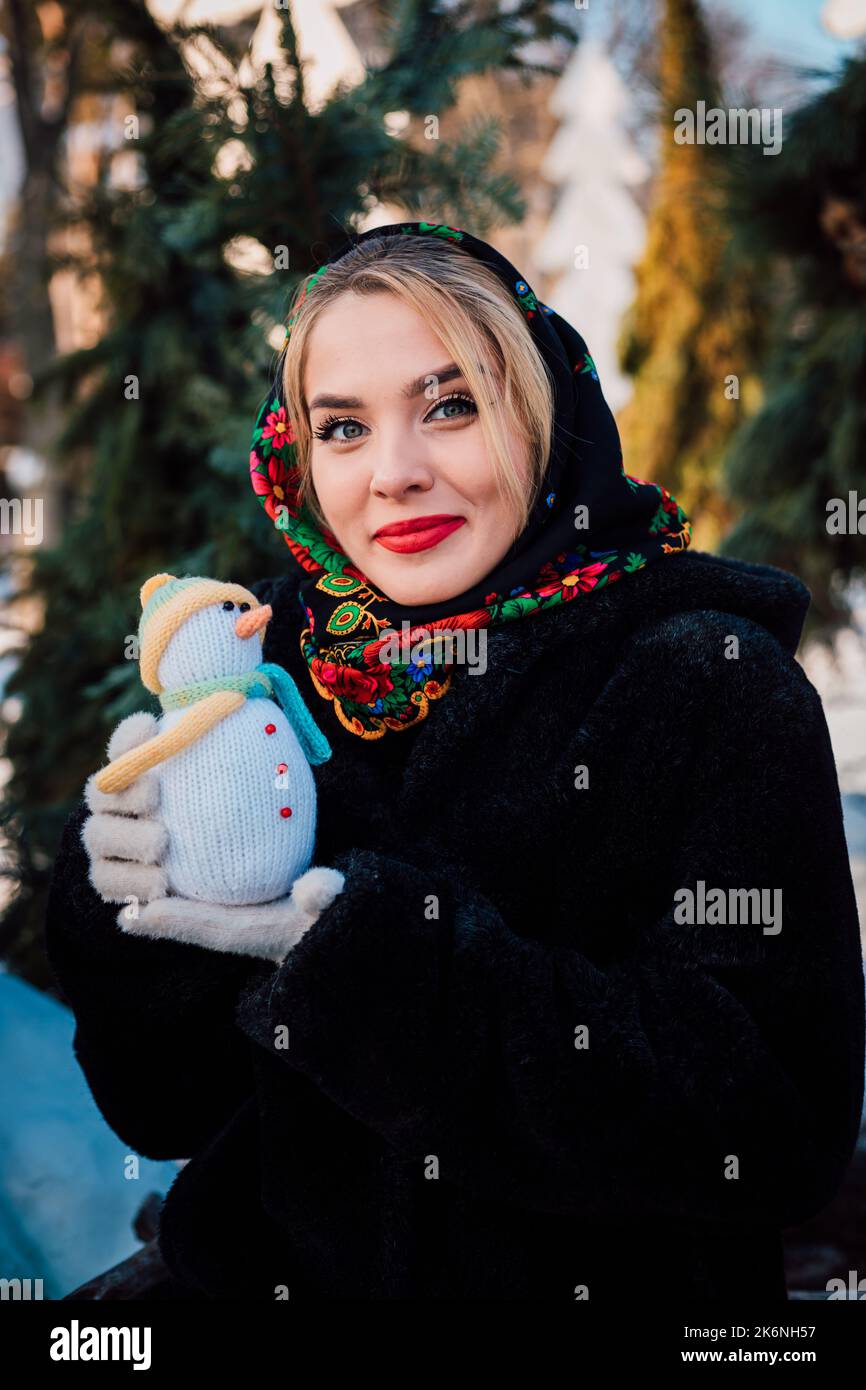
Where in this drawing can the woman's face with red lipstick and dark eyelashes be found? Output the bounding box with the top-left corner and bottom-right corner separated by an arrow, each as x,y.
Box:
304,292 -> 530,606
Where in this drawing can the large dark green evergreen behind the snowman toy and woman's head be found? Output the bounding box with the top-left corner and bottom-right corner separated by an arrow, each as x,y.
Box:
3,0 -> 583,984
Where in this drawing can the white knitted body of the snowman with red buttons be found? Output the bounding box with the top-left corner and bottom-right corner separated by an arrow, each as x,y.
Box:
157,698 -> 316,905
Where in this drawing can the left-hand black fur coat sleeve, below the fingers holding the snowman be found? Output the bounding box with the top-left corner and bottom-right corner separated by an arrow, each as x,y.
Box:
40,801 -> 271,1158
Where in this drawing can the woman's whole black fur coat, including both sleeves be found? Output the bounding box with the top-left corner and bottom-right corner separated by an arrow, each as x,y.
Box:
47,552 -> 865,1305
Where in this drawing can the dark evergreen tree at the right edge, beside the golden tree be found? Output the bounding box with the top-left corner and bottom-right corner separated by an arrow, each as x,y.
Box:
723,58 -> 866,638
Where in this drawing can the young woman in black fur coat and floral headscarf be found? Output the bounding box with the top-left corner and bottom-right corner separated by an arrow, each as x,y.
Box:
47,222 -> 865,1307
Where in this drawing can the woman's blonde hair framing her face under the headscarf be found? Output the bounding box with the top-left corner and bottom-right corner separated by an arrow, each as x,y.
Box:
282,234 -> 553,537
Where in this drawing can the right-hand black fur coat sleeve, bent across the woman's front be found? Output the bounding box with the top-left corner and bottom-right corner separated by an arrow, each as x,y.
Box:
238,614 -> 863,1226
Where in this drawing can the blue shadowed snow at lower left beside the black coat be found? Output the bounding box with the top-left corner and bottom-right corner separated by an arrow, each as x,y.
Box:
0,973 -> 178,1298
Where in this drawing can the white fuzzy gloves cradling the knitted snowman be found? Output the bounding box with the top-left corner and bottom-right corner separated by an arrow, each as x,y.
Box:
82,712 -> 343,962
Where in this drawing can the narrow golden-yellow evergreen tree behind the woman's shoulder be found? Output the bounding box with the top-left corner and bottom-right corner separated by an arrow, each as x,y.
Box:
620,0 -> 771,549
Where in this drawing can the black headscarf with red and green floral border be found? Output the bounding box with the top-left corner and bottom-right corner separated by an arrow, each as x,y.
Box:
250,222 -> 691,739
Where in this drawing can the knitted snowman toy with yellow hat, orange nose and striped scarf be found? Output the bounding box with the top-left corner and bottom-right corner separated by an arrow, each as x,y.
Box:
93,574 -> 343,958
